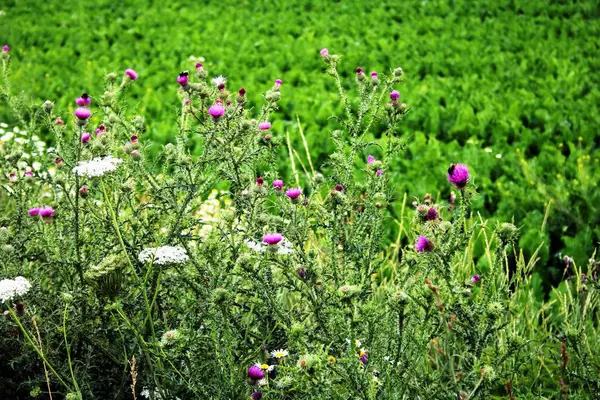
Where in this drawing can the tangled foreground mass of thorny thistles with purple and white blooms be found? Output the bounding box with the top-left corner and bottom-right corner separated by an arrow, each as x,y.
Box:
0,49 -> 600,399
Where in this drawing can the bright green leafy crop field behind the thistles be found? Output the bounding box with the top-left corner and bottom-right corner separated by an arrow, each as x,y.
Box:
0,0 -> 600,282
